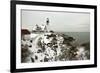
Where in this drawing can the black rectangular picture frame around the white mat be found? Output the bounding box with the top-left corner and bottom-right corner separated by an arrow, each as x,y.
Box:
10,1 -> 97,72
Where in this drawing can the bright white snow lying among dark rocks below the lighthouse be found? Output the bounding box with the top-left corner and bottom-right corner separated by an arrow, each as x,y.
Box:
22,32 -> 90,62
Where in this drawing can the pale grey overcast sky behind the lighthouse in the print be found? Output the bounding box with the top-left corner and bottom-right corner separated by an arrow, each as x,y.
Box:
21,10 -> 90,32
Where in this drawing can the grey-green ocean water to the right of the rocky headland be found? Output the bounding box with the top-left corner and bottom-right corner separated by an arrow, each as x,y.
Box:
56,32 -> 90,44
